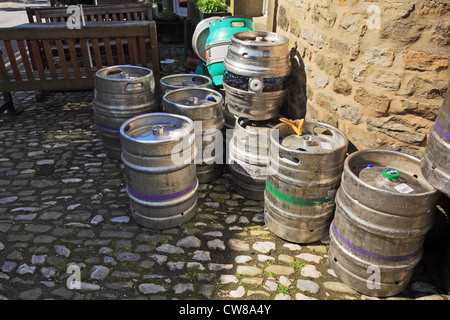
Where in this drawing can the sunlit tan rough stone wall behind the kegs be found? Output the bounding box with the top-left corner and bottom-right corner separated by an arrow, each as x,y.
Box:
269,0 -> 450,157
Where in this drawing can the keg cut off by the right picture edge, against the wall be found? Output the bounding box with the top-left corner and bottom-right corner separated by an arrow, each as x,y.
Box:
420,82 -> 450,197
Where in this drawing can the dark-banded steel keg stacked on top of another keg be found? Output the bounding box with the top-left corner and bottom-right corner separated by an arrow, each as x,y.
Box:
223,31 -> 291,120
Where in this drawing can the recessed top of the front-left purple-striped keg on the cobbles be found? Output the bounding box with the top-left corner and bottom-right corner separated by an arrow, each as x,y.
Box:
120,113 -> 193,142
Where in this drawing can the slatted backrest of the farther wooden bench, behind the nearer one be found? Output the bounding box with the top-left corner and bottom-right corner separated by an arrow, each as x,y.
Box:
26,3 -> 153,23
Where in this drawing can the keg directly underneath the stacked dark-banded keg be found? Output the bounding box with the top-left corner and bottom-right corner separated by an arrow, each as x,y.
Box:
228,118 -> 278,200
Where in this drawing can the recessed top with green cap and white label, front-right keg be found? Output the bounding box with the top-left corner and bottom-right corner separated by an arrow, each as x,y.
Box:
345,150 -> 435,195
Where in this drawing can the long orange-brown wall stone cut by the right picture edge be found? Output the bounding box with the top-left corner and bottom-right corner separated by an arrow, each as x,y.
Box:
403,51 -> 448,71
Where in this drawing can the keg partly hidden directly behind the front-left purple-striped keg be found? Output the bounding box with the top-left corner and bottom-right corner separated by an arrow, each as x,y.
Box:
163,88 -> 225,183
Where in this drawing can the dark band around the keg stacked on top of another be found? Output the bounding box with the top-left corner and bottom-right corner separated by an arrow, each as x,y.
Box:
223,69 -> 289,92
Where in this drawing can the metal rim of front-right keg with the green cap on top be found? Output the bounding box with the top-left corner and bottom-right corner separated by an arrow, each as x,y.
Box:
342,149 -> 439,198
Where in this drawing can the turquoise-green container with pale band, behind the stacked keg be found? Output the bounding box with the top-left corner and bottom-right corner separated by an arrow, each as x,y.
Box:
205,16 -> 254,86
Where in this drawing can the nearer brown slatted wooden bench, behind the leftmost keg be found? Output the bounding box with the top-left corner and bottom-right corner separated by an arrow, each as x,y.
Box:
0,21 -> 161,113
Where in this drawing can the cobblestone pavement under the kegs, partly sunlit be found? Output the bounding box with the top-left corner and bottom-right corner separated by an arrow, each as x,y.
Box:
0,43 -> 450,300
